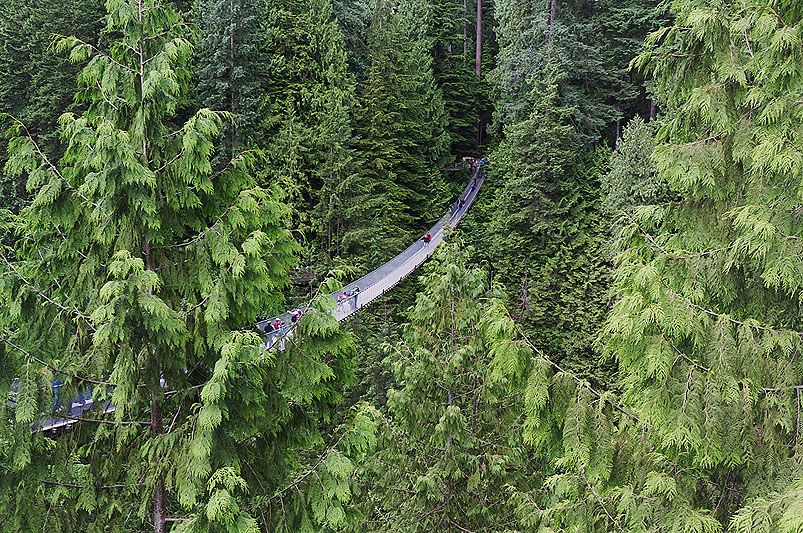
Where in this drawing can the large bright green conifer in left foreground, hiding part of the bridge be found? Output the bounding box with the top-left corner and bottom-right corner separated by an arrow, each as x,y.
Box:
0,0 -> 374,532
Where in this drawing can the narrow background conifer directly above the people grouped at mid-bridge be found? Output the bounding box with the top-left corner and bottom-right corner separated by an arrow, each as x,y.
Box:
261,0 -> 356,260
